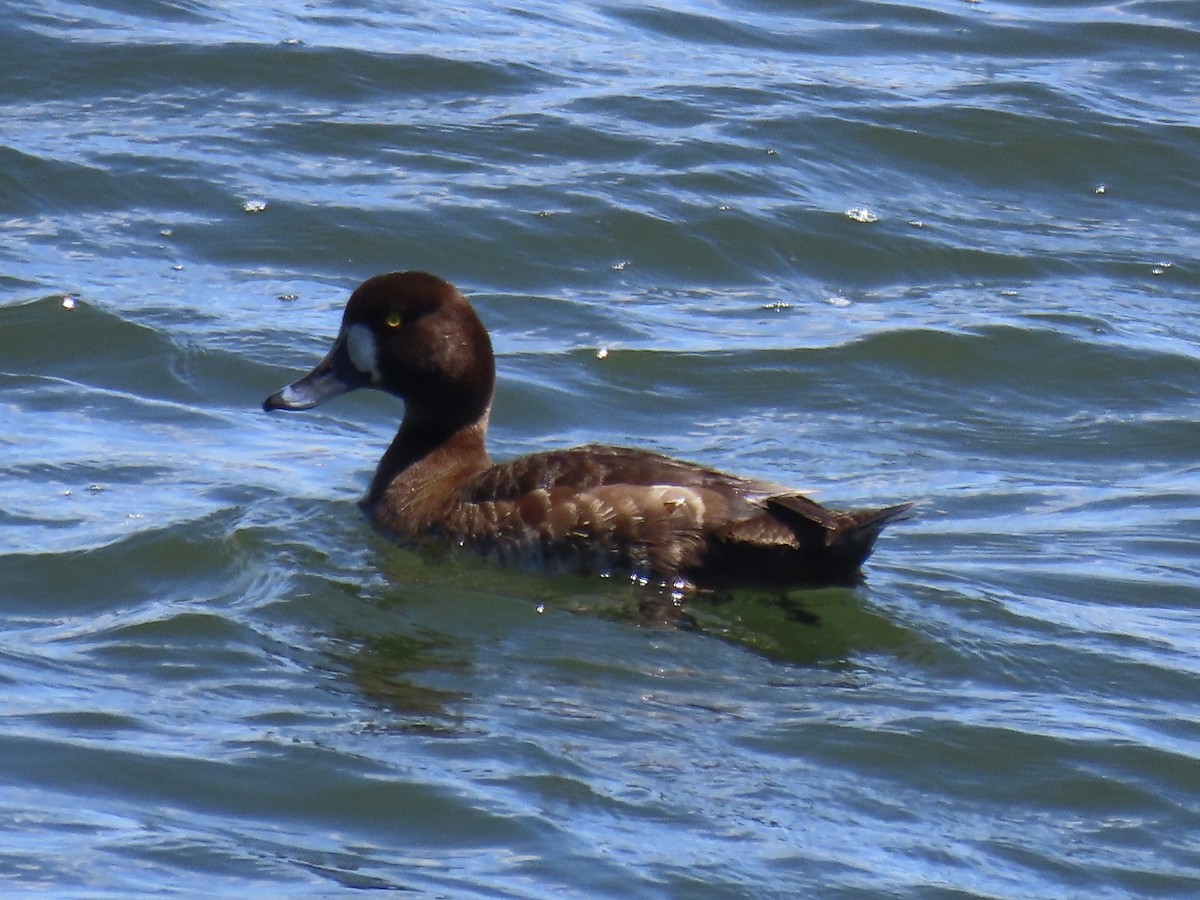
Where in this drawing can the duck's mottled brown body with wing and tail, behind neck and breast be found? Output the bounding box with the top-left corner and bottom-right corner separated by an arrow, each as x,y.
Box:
458,445 -> 911,587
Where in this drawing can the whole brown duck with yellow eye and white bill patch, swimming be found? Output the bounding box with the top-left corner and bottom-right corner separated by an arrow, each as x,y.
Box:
263,271 -> 913,593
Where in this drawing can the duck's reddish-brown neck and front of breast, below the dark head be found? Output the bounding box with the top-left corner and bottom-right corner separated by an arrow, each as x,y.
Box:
361,407 -> 491,509
